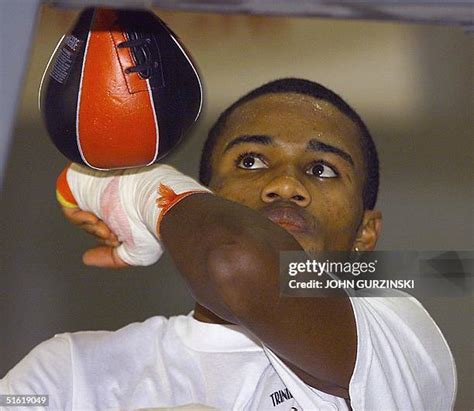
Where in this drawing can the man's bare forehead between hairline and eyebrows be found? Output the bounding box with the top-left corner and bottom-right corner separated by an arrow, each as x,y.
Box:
216,93 -> 362,162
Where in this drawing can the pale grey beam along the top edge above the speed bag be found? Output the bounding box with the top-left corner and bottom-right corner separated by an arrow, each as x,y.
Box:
49,0 -> 474,31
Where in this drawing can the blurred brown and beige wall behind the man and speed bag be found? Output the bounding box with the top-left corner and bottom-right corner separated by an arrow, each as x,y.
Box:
0,6 -> 474,410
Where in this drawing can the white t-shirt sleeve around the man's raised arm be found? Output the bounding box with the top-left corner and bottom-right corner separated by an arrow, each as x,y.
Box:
264,290 -> 457,411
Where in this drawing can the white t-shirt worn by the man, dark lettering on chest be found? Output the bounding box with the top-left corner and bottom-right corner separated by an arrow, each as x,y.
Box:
0,291 -> 456,411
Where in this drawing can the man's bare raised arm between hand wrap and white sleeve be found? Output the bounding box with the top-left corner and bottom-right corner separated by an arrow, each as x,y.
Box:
161,194 -> 356,398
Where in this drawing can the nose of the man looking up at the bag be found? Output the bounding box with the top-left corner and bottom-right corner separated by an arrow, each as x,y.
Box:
262,175 -> 311,207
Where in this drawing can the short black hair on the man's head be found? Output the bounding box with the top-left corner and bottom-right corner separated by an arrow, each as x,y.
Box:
199,78 -> 379,210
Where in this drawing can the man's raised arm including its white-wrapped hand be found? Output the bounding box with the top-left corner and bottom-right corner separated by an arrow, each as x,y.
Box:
58,162 -> 356,397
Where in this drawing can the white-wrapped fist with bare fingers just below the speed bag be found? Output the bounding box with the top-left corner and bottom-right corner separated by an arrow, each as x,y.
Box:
56,164 -> 163,268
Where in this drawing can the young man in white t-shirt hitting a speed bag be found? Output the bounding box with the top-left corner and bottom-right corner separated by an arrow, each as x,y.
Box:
0,79 -> 456,410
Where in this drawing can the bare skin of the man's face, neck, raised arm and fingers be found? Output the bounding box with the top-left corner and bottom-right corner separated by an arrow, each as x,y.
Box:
63,93 -> 381,398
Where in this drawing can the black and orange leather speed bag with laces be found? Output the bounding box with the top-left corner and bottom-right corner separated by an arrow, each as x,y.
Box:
40,9 -> 202,169
